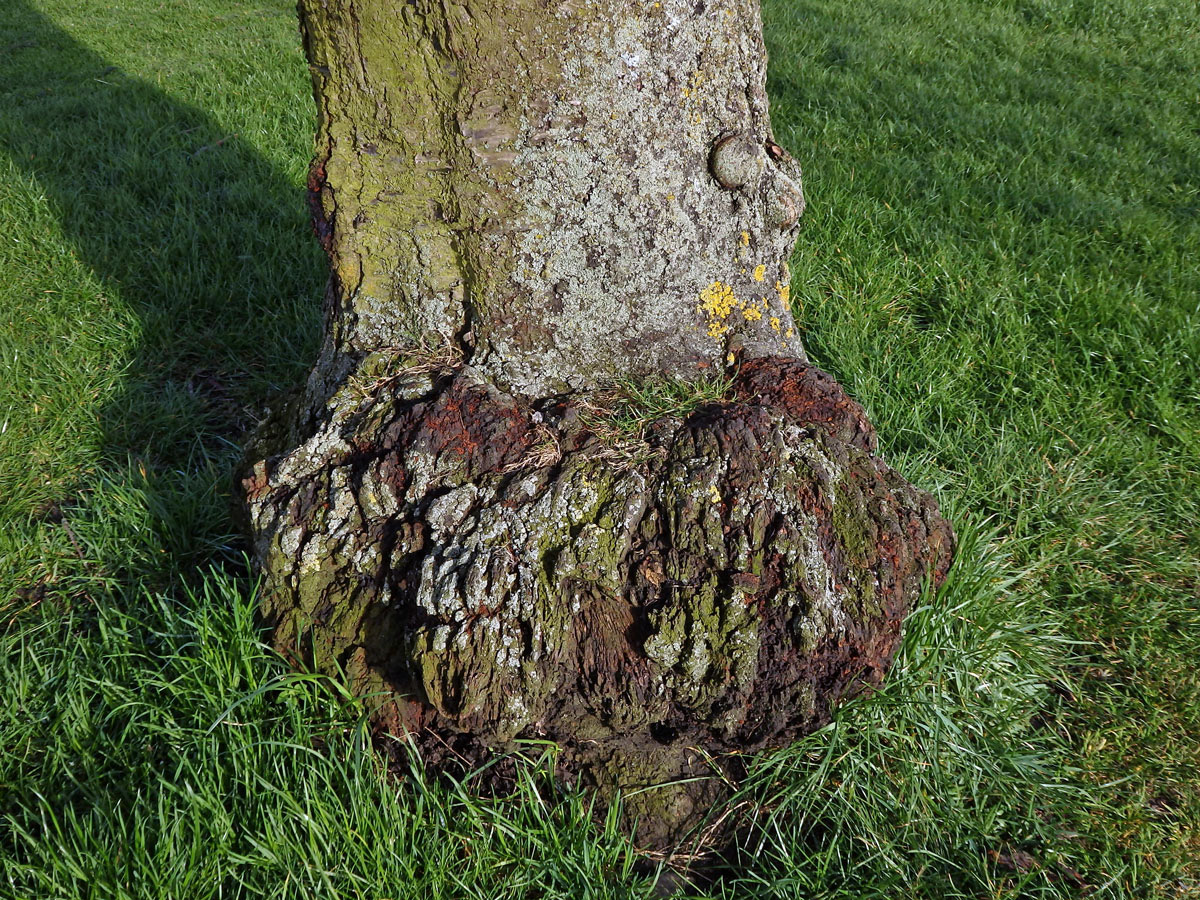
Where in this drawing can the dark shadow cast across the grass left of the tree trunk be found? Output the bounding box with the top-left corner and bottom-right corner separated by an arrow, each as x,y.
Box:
0,0 -> 324,578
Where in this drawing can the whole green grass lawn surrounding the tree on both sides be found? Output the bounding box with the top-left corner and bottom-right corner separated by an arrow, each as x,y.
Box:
0,0 -> 1200,898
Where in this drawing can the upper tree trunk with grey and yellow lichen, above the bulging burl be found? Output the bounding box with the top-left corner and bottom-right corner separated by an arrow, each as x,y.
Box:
301,0 -> 804,397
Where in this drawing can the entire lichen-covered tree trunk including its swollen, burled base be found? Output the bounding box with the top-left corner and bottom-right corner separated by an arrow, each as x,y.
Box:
241,0 -> 954,847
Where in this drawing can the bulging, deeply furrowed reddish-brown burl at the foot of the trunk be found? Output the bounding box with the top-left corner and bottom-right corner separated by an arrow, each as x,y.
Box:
241,358 -> 954,847
